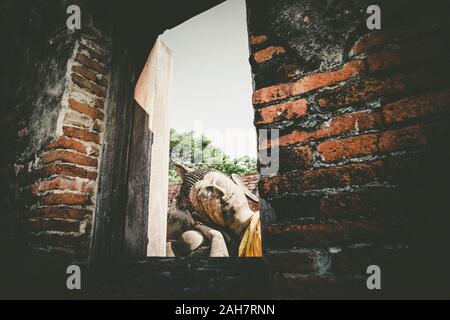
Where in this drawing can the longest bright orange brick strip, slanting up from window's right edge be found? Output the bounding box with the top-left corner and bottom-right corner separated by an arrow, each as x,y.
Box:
253,60 -> 364,105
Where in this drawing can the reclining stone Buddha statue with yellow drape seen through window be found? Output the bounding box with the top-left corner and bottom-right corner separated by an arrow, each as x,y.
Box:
167,161 -> 262,257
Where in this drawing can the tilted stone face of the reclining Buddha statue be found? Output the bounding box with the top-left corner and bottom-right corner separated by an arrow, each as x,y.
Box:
191,172 -> 250,226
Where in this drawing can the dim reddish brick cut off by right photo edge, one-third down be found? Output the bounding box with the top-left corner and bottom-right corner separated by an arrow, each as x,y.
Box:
383,90 -> 450,124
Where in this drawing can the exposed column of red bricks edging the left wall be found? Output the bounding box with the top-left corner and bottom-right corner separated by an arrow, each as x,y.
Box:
29,37 -> 109,260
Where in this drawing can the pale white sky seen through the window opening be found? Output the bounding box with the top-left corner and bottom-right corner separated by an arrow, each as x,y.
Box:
161,0 -> 256,158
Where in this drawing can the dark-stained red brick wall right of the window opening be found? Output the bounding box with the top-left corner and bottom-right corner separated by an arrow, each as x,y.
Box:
248,1 -> 450,297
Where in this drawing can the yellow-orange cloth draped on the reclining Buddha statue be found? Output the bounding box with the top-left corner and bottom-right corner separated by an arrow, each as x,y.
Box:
239,212 -> 262,257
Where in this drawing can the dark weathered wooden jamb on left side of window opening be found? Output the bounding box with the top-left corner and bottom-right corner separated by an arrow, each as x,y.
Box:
89,1 -> 265,269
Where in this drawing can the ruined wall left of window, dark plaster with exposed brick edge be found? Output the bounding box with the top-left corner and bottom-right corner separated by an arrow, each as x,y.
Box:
1,1 -> 110,260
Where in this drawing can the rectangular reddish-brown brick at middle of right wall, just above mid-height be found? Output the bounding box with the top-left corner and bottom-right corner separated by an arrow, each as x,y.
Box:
317,134 -> 378,162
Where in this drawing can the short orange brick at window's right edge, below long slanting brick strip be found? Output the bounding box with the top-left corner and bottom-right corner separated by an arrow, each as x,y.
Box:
255,99 -> 307,124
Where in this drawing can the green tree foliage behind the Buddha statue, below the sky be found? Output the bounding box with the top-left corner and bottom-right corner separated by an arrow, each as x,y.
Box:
169,129 -> 256,184
